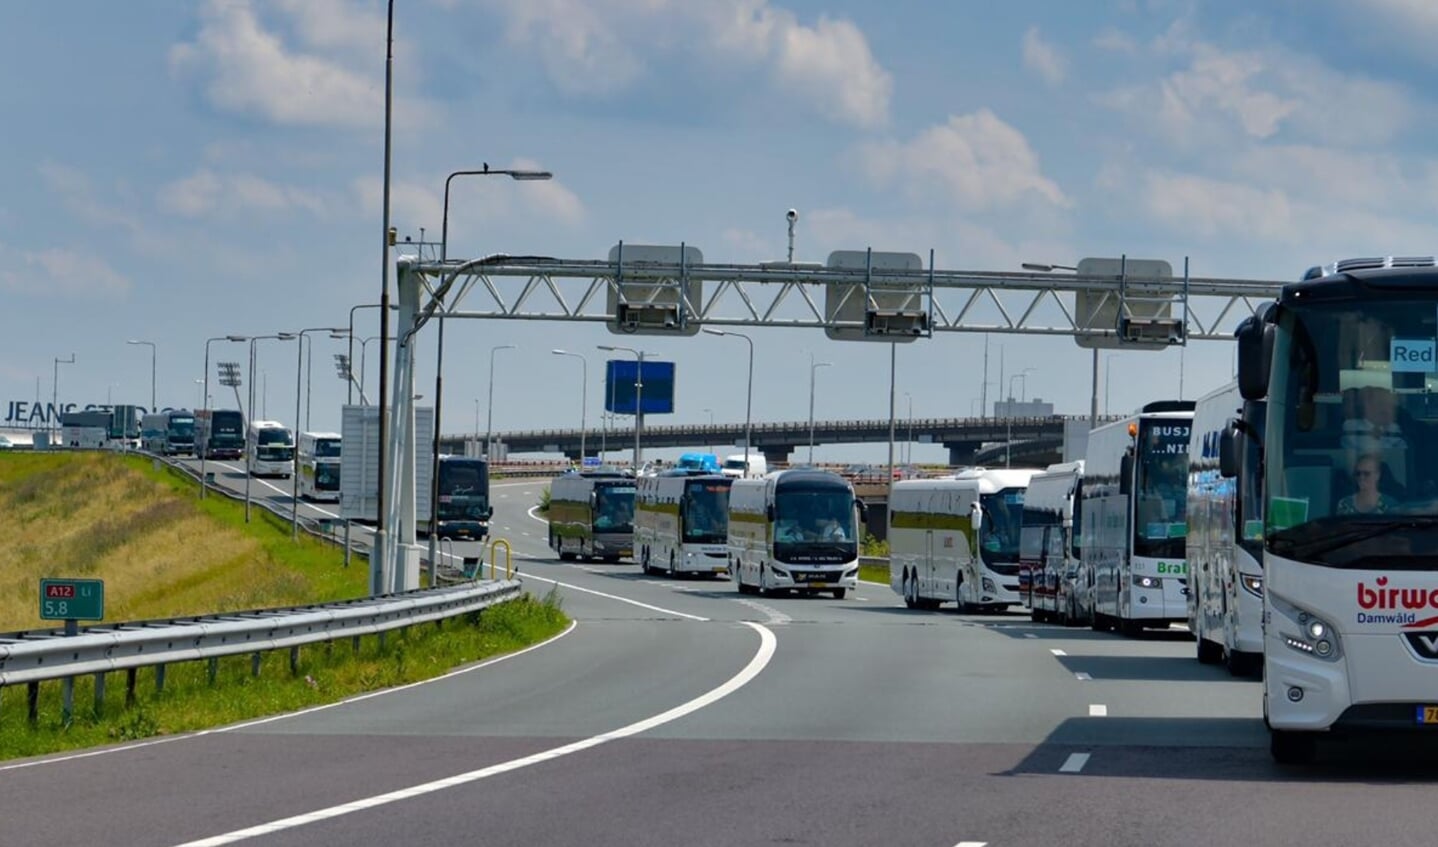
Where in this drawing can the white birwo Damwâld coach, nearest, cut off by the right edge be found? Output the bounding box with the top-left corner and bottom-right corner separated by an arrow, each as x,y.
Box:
1219,257 -> 1438,762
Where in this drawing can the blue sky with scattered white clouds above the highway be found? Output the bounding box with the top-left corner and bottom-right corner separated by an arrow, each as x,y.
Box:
0,0 -> 1438,460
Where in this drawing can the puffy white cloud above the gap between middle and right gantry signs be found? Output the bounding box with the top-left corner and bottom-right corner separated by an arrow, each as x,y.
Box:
860,109 -> 1073,211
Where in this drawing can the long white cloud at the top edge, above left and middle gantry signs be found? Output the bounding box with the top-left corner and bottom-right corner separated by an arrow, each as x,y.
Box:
490,0 -> 893,128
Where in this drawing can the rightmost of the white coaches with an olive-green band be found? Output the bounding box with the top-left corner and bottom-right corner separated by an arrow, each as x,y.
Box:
889,467 -> 1038,611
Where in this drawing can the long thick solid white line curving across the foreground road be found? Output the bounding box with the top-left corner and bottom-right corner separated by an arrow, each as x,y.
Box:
168,621 -> 778,847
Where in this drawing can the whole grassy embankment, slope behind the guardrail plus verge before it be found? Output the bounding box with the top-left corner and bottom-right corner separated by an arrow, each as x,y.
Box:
0,453 -> 568,758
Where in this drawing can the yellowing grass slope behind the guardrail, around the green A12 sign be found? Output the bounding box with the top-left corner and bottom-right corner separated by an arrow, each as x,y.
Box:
0,453 -> 359,631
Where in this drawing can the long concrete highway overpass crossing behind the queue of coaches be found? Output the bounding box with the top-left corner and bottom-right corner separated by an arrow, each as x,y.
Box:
440,416 -> 1117,464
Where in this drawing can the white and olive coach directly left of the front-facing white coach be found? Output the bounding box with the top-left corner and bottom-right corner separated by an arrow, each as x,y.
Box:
634,470 -> 733,577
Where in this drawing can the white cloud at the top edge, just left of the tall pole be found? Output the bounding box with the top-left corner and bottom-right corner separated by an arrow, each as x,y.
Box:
170,0 -> 384,127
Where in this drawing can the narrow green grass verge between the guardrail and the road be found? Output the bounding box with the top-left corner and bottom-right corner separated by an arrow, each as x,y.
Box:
0,592 -> 568,759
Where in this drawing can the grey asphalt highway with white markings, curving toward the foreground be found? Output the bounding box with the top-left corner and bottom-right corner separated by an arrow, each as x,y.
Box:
0,483 -> 1438,847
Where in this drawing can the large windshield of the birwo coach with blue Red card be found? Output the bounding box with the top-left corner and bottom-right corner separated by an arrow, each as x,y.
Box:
1264,295 -> 1438,569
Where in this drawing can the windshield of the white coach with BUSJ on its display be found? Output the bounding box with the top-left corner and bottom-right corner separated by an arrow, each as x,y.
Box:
1133,418 -> 1192,559
